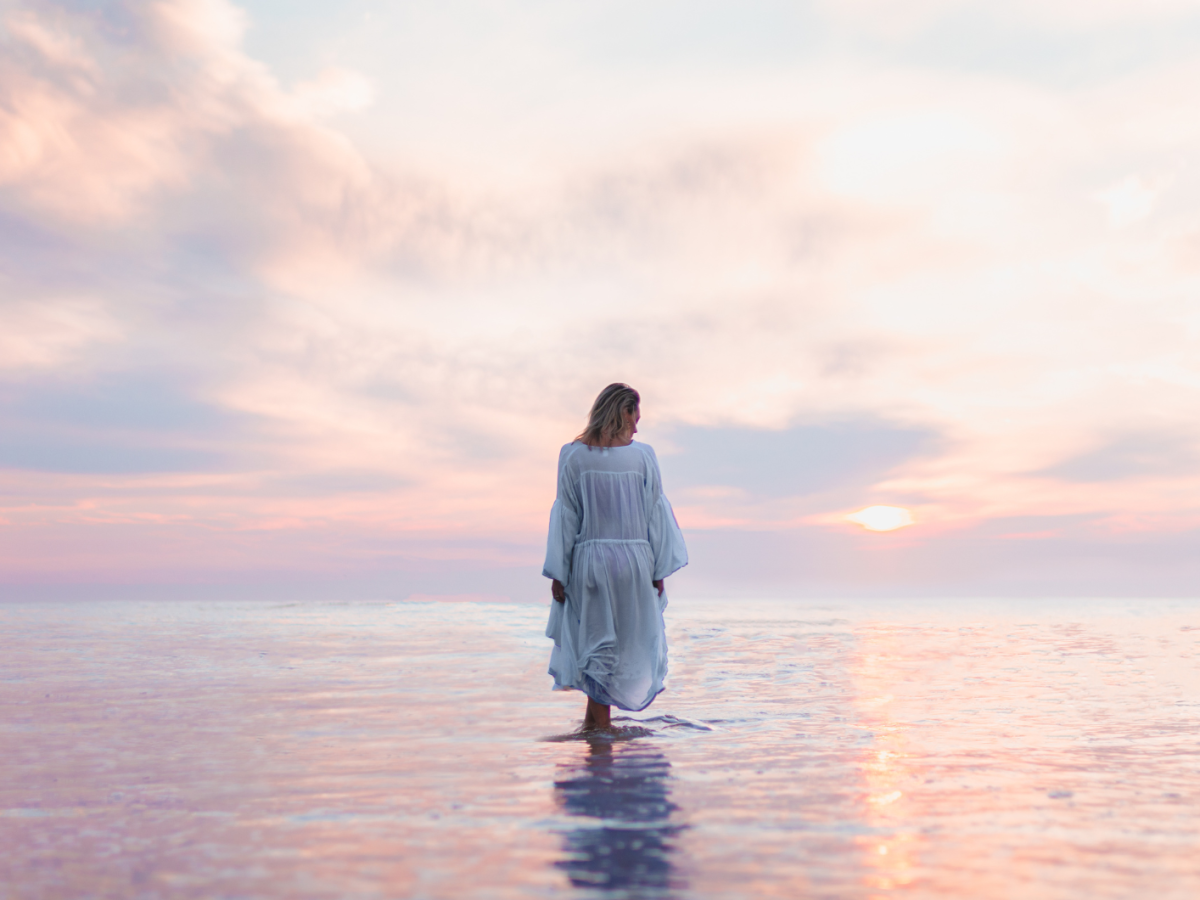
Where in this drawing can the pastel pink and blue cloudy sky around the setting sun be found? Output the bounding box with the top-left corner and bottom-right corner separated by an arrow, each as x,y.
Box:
0,0 -> 1200,600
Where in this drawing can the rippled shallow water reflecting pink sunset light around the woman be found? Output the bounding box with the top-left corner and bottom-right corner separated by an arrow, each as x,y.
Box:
0,600 -> 1200,900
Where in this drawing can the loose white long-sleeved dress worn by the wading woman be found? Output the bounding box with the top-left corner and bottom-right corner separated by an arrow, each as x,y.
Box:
541,442 -> 688,712
